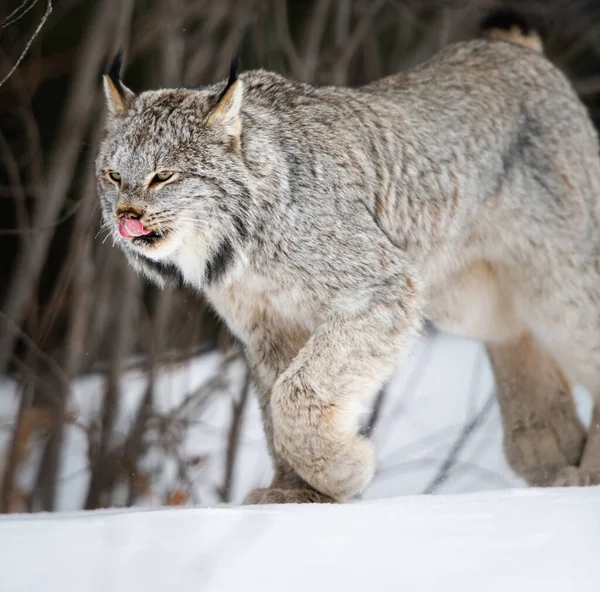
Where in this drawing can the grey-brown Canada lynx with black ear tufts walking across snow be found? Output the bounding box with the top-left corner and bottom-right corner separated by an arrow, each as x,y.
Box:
97,15 -> 600,503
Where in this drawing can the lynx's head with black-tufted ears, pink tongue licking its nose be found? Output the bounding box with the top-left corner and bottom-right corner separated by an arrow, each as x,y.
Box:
96,54 -> 251,287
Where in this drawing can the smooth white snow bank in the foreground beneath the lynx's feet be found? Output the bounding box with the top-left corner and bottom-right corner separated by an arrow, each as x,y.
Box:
0,488 -> 600,592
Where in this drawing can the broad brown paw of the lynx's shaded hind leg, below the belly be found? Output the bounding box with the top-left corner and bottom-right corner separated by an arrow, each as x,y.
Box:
505,421 -> 586,487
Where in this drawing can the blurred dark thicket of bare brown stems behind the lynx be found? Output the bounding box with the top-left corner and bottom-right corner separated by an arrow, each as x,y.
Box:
0,0 -> 600,512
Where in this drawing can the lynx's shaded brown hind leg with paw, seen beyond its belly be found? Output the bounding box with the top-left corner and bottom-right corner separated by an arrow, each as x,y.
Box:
487,333 -> 586,486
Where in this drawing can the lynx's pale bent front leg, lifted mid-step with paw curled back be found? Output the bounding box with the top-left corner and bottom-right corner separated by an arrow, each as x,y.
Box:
271,275 -> 421,501
